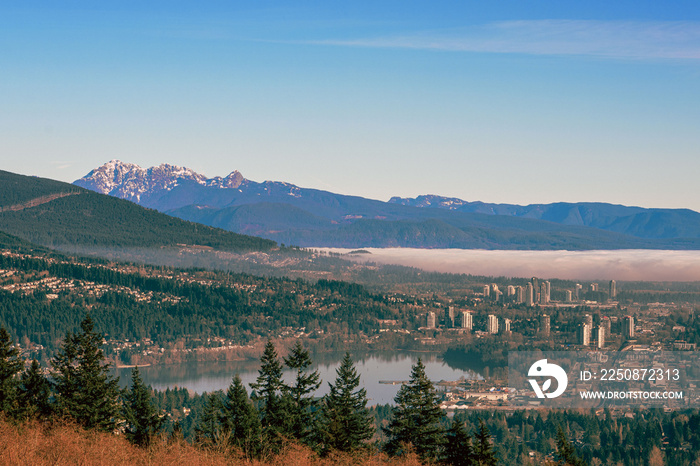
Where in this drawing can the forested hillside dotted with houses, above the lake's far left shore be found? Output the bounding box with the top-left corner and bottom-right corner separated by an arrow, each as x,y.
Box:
0,248 -> 414,362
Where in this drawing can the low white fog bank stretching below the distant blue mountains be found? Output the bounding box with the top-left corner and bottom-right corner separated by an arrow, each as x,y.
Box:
317,248 -> 700,281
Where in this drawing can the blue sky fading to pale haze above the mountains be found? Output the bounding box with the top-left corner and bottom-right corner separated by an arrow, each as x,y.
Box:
0,0 -> 700,210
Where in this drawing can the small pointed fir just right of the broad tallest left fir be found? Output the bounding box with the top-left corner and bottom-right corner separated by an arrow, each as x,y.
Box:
124,367 -> 164,447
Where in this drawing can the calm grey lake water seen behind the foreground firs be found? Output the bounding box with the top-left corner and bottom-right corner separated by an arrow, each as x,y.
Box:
116,352 -> 481,405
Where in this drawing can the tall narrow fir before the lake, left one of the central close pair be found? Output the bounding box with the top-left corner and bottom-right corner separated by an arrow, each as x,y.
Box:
250,340 -> 289,443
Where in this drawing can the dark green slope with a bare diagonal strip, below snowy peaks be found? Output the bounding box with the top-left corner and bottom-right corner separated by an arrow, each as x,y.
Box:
0,171 -> 276,251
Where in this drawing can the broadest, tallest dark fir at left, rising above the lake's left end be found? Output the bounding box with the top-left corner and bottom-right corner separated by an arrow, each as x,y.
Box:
52,315 -> 119,432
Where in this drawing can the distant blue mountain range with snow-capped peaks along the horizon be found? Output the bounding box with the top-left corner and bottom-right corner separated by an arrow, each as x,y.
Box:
74,160 -> 700,250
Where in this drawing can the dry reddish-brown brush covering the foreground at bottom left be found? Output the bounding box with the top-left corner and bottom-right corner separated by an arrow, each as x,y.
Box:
0,419 -> 421,466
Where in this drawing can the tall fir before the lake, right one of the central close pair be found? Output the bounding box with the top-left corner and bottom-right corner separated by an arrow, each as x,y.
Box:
284,341 -> 321,446
